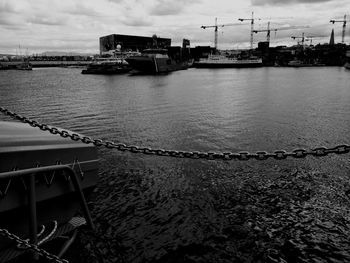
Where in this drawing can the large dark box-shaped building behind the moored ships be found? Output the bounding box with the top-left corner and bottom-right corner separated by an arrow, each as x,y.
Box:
100,34 -> 171,55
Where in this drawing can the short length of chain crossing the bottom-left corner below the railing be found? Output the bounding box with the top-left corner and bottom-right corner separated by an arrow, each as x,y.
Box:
0,228 -> 69,263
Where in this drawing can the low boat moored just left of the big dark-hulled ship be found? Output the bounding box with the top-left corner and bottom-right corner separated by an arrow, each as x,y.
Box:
81,58 -> 131,75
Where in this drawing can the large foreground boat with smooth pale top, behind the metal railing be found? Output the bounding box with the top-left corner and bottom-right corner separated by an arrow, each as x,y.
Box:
0,121 -> 98,262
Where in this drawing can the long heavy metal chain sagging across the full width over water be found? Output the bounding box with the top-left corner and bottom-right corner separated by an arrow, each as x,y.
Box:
0,107 -> 350,161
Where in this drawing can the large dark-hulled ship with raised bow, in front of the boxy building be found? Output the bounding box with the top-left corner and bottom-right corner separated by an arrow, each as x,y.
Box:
125,48 -> 190,74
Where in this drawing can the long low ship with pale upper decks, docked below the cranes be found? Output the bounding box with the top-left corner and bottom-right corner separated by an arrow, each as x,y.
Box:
193,55 -> 263,68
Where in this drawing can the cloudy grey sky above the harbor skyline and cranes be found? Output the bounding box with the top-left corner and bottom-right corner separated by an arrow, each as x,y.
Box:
0,0 -> 350,54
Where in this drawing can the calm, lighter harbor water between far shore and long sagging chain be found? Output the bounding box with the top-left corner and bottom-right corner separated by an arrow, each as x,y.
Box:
0,67 -> 350,151
